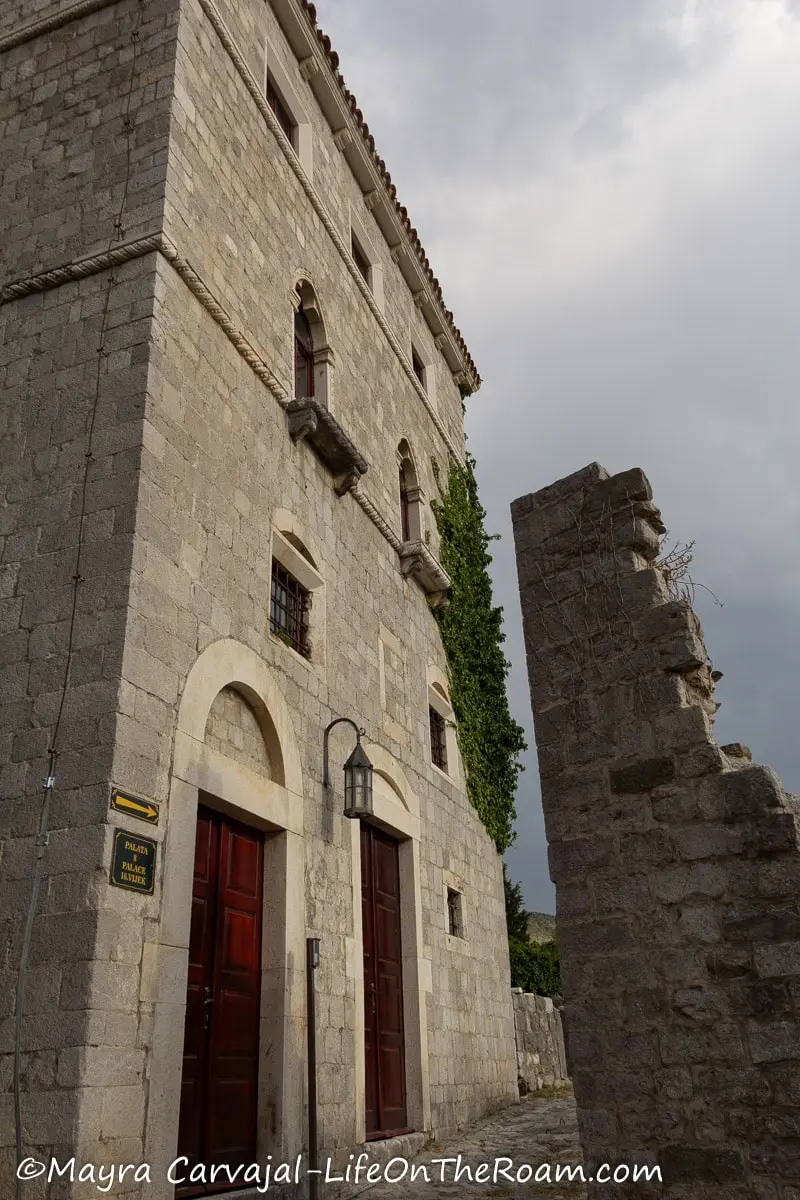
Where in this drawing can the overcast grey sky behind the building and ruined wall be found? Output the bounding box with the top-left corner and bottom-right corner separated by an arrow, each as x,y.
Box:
318,0 -> 800,912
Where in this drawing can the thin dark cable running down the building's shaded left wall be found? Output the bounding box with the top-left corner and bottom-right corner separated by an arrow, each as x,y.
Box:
13,0 -> 145,1200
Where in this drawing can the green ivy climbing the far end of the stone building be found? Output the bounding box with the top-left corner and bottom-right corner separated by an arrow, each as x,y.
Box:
431,455 -> 525,853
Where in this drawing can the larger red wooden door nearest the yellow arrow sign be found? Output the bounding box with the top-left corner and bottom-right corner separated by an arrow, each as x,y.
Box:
178,808 -> 264,1192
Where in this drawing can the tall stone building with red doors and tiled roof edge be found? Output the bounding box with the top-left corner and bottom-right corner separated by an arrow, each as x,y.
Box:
0,0 -> 517,1198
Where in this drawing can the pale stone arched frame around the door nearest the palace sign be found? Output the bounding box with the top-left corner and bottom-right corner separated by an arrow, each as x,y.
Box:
140,638 -> 306,1200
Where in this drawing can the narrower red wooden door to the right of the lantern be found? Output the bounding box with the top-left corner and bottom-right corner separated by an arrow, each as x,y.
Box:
361,824 -> 408,1138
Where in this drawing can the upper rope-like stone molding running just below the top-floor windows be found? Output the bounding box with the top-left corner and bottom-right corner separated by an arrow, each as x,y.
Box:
199,0 -> 464,466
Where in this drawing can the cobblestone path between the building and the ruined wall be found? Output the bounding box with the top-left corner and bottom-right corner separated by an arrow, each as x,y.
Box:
352,1093 -> 587,1200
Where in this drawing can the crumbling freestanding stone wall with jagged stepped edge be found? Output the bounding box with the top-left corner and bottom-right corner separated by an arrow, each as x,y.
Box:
512,463 -> 800,1200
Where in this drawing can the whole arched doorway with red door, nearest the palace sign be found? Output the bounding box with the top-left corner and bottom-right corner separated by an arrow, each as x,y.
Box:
146,640 -> 305,1200
